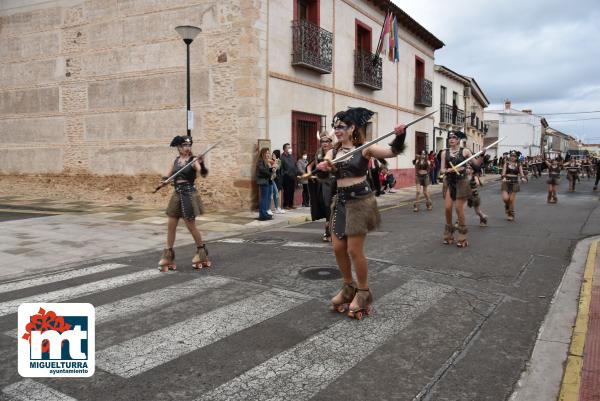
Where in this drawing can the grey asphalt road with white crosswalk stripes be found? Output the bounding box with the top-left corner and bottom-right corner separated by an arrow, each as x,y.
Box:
0,179 -> 600,401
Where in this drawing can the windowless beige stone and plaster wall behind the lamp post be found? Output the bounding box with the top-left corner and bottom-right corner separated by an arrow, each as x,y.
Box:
0,0 -> 267,208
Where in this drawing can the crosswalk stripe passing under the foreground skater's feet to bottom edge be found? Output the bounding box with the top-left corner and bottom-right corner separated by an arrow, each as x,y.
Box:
199,280 -> 450,401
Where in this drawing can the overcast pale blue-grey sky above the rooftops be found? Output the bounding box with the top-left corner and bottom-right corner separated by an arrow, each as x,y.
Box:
394,0 -> 600,143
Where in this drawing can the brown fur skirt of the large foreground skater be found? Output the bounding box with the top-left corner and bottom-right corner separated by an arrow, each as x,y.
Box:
331,181 -> 381,239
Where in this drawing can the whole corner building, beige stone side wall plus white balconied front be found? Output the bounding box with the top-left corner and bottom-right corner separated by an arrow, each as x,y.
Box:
0,0 -> 443,208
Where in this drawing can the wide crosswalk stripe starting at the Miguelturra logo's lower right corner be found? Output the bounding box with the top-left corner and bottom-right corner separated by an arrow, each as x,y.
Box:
96,289 -> 309,378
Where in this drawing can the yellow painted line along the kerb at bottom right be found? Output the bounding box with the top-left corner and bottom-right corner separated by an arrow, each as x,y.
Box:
558,241 -> 600,401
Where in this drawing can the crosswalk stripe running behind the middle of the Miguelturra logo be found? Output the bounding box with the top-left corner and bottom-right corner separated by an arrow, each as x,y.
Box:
4,276 -> 232,337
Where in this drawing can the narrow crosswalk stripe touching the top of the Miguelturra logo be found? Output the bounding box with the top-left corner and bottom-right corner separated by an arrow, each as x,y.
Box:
0,269 -> 164,316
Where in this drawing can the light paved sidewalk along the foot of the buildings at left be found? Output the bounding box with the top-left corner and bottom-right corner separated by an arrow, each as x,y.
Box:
0,180 -> 450,280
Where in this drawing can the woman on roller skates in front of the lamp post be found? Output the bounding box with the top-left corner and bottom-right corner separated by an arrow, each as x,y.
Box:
158,136 -> 211,272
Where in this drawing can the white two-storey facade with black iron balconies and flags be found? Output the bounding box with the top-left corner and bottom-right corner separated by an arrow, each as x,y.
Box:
265,0 -> 443,186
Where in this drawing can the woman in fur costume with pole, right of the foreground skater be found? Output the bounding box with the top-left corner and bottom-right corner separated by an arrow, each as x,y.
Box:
440,132 -> 484,248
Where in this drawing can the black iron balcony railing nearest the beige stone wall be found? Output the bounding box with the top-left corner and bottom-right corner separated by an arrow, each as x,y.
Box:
292,20 -> 333,74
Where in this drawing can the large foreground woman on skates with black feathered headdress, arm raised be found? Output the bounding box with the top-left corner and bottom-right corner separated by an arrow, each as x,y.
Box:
317,108 -> 406,320
